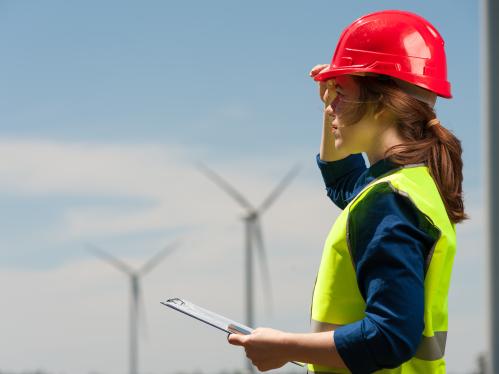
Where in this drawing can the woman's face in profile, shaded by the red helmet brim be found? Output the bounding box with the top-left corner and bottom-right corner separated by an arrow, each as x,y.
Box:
326,75 -> 378,154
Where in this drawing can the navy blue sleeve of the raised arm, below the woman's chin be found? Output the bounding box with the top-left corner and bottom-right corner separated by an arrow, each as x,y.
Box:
317,153 -> 367,209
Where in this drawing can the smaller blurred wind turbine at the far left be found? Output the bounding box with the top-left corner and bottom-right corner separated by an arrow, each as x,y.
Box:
87,243 -> 178,374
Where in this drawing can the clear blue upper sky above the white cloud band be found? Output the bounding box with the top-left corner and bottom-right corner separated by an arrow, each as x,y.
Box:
0,1 -> 479,157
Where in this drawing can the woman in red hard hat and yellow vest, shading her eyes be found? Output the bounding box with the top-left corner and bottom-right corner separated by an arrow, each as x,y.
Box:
229,11 -> 466,374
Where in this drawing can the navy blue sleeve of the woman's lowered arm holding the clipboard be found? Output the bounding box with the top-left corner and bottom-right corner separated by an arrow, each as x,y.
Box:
334,184 -> 439,373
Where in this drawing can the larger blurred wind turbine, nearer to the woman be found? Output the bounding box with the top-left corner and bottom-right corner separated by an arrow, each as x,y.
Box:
198,163 -> 299,330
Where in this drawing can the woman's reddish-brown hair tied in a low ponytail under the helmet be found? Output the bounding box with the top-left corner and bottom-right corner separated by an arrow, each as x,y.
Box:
341,76 -> 467,223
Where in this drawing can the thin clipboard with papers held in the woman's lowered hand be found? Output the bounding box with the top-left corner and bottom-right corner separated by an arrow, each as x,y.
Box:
161,297 -> 305,366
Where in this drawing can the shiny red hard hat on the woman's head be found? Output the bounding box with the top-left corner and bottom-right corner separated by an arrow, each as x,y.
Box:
314,10 -> 452,98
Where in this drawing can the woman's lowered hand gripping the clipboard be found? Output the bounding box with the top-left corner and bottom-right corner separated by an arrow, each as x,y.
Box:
228,328 -> 291,371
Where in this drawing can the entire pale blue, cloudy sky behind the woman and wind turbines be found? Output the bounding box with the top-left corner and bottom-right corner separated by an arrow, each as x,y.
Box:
0,0 -> 487,374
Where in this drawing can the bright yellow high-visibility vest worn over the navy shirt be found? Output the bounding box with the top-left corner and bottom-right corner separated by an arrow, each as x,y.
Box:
308,165 -> 456,374
